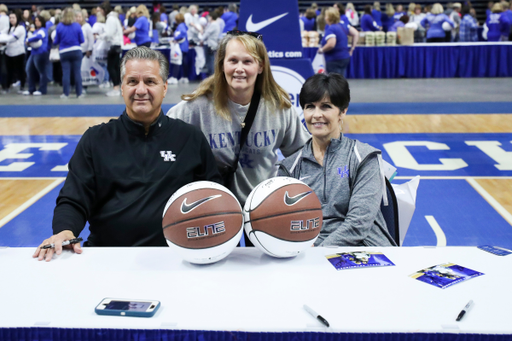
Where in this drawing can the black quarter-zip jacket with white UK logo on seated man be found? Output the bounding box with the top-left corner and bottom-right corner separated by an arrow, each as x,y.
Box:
53,112 -> 221,246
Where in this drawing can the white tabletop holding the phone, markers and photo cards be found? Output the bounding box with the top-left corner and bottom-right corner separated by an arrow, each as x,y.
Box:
0,247 -> 512,337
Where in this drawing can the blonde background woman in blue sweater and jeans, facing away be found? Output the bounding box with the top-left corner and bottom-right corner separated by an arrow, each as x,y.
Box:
53,7 -> 85,99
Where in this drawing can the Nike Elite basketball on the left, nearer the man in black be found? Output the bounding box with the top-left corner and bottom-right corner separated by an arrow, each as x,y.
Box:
162,181 -> 243,264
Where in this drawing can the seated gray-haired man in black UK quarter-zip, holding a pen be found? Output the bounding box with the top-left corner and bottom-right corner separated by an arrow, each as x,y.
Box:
33,46 -> 221,261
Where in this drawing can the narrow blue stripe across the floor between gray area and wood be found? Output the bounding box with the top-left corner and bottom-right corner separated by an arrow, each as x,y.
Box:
0,102 -> 512,117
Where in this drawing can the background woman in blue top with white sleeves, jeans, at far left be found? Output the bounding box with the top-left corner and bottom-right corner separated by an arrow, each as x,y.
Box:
23,15 -> 49,96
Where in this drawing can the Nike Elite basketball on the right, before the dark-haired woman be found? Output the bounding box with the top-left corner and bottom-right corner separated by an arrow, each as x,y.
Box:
244,177 -> 322,258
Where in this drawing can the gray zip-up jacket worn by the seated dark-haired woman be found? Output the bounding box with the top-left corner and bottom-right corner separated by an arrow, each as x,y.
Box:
278,134 -> 396,246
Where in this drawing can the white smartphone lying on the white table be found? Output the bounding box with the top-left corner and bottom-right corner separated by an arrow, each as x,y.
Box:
94,298 -> 160,317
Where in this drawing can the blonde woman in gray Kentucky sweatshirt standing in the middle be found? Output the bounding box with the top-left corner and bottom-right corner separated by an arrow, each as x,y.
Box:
167,30 -> 310,207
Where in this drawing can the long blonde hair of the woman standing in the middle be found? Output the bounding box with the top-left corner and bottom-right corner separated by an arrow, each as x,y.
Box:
181,34 -> 292,121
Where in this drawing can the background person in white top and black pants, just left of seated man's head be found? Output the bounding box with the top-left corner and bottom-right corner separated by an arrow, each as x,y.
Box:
97,1 -> 123,97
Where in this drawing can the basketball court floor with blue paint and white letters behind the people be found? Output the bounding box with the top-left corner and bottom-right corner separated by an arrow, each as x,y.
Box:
0,78 -> 512,248
